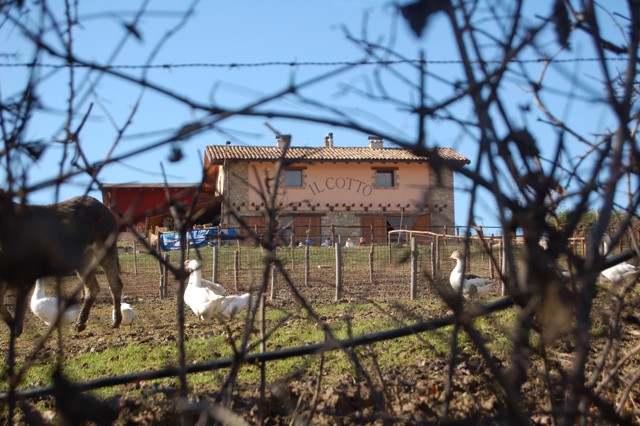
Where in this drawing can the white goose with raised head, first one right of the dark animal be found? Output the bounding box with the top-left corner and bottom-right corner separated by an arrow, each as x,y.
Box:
184,259 -> 246,321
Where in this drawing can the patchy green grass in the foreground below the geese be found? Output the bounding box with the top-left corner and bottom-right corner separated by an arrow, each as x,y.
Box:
2,286 -> 520,424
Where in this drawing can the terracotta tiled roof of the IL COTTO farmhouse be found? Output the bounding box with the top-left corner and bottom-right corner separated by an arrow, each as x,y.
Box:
205,145 -> 469,164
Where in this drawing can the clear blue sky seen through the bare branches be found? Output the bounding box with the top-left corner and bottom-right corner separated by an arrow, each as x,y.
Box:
0,0 -> 636,225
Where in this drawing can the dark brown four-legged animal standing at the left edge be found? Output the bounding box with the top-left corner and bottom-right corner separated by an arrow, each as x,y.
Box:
0,193 -> 122,336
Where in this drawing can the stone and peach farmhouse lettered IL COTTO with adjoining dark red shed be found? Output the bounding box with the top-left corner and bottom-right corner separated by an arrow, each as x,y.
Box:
103,133 -> 469,245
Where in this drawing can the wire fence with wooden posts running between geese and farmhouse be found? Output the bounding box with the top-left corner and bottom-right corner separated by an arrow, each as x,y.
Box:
110,231 -> 604,303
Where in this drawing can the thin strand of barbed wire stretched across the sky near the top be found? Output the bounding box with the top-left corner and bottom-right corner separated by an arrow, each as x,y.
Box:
0,57 -> 628,70
